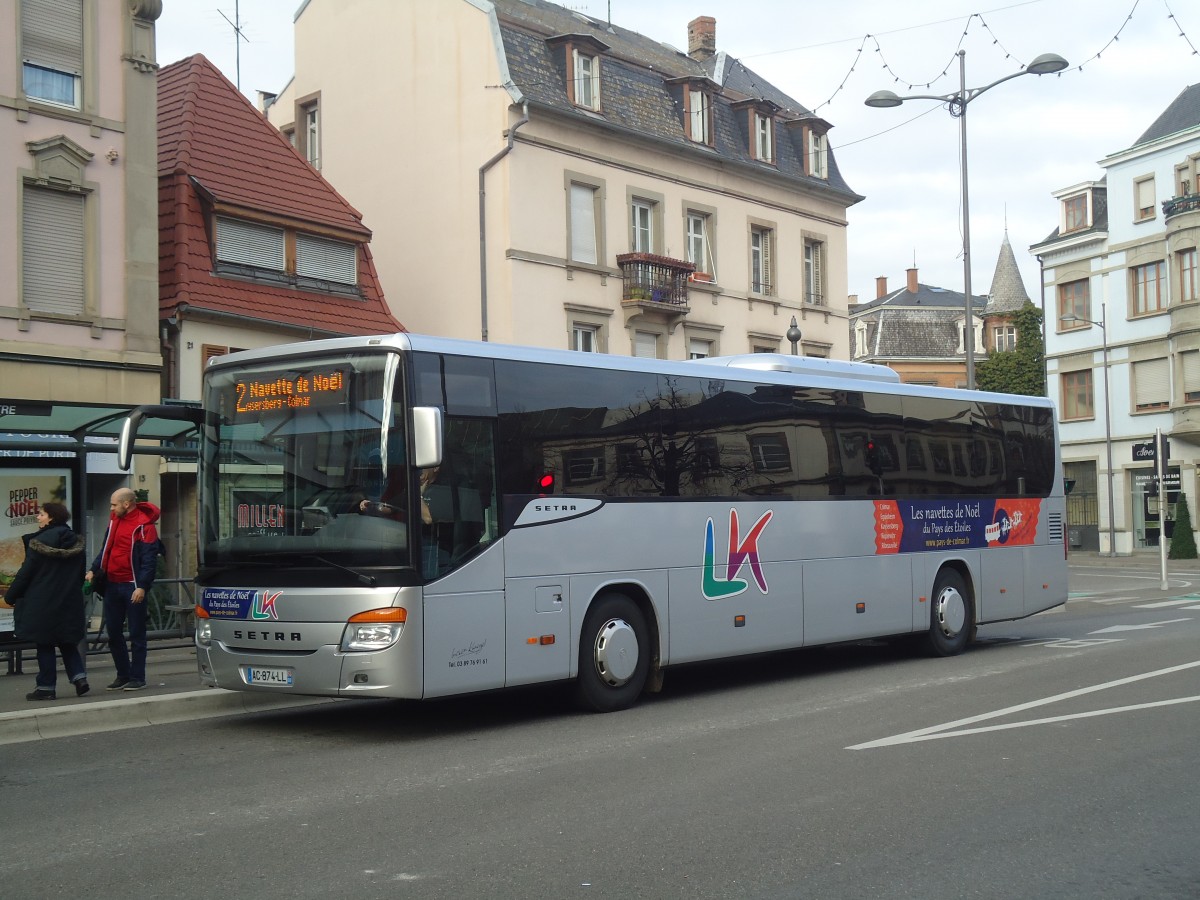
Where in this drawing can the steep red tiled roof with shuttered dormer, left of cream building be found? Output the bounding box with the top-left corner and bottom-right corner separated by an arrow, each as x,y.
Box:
158,54 -> 403,335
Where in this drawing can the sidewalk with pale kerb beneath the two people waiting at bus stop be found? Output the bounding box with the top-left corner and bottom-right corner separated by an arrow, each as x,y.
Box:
0,638 -> 329,745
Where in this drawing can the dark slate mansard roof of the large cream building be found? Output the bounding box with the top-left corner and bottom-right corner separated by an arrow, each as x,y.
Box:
492,0 -> 863,205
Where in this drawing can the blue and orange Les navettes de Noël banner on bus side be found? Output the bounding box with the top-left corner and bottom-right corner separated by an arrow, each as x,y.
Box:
875,497 -> 1042,553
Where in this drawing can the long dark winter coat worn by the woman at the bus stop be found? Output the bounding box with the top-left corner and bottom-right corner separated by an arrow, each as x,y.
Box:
5,524 -> 88,644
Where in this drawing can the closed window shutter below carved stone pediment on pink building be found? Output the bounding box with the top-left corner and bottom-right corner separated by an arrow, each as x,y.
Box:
22,186 -> 84,316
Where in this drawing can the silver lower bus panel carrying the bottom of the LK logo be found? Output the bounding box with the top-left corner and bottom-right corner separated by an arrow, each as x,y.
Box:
671,562 -> 804,664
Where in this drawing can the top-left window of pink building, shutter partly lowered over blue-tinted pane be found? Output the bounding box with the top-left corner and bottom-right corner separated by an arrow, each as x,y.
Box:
20,0 -> 84,109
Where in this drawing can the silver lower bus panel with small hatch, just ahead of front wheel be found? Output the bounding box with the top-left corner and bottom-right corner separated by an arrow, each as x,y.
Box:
504,575 -> 571,686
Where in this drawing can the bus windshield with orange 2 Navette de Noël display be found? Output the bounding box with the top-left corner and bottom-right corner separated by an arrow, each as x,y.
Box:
199,352 -> 412,568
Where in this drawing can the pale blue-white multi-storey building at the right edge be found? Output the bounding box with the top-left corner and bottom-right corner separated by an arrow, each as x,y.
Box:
1030,85 -> 1200,554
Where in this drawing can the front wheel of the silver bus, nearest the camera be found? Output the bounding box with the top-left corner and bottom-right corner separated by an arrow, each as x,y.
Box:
575,594 -> 650,713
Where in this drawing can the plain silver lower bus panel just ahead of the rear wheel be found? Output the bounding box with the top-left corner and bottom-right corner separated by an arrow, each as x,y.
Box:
804,553 -> 912,646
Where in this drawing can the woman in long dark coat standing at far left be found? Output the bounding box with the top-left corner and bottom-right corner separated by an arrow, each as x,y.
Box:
5,503 -> 89,700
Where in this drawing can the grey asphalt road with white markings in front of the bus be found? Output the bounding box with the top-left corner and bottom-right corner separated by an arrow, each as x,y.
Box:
0,565 -> 1200,900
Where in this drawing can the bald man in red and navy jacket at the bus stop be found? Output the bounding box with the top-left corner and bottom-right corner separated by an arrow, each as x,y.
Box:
84,487 -> 161,691
